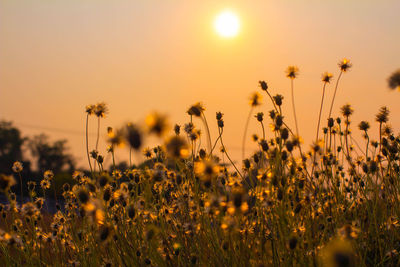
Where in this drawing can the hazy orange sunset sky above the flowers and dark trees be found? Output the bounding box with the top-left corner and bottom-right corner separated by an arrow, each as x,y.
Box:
0,0 -> 400,170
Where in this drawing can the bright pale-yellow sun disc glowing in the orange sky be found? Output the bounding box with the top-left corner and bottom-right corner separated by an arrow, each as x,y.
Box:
214,10 -> 240,38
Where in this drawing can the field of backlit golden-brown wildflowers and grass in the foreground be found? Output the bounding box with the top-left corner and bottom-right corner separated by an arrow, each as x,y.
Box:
0,59 -> 400,266
